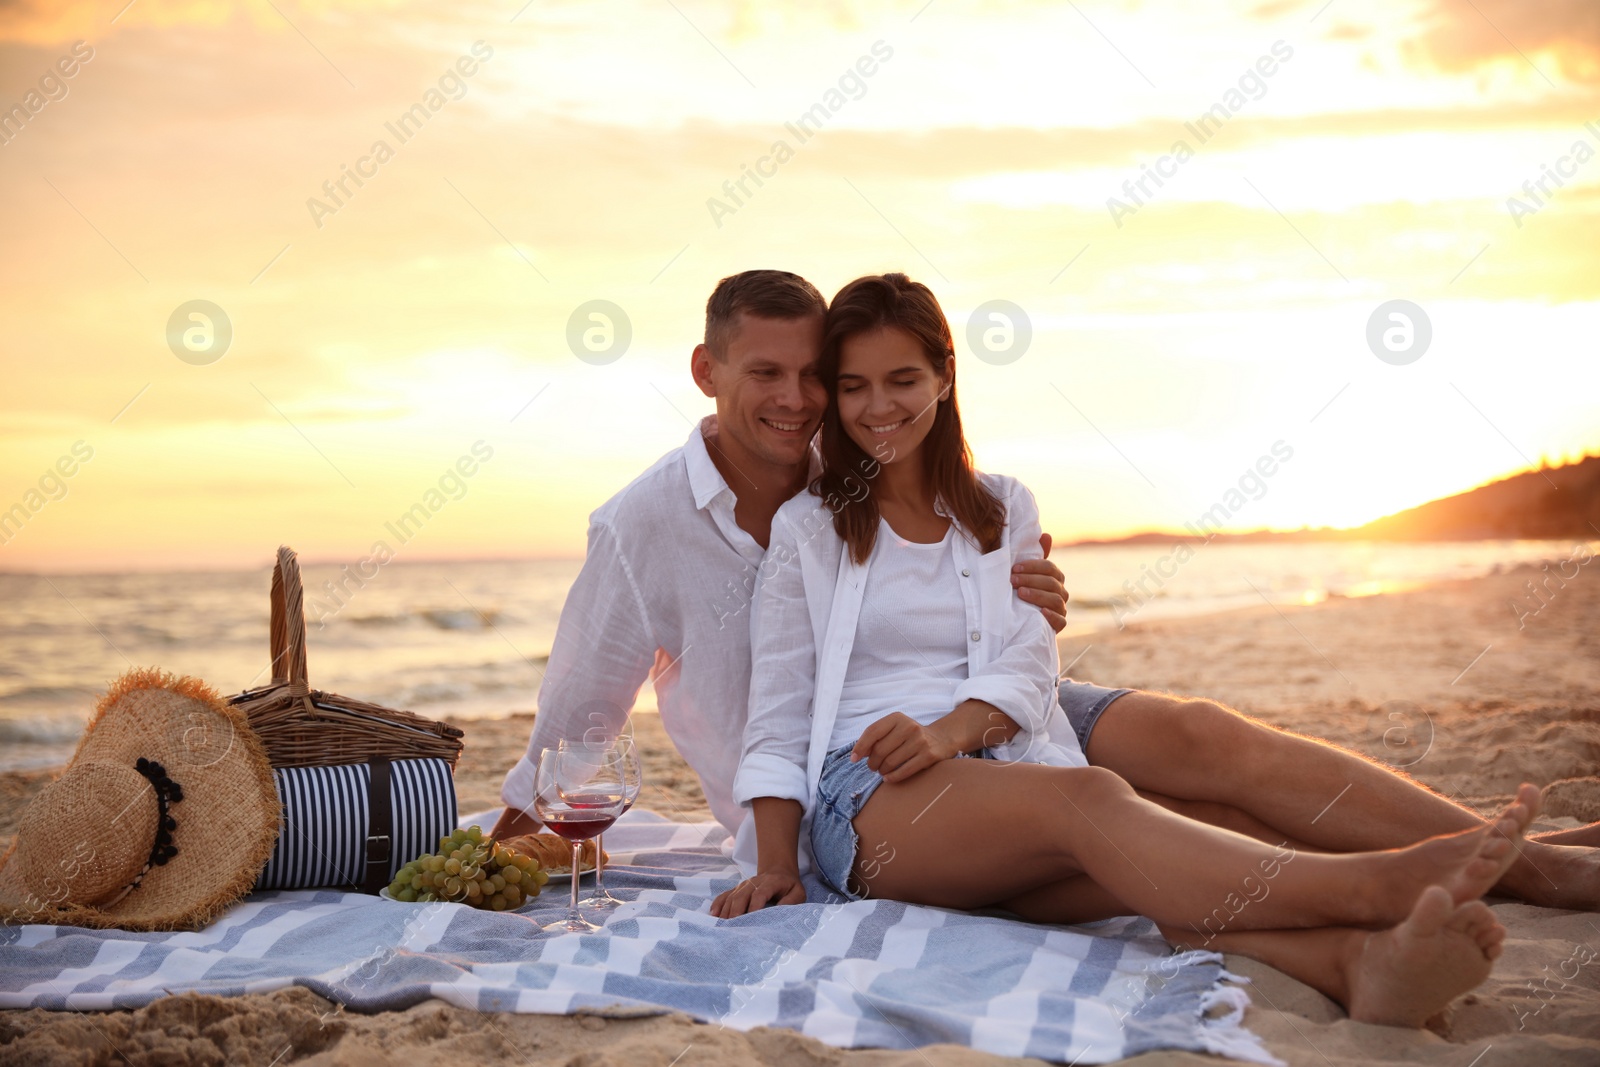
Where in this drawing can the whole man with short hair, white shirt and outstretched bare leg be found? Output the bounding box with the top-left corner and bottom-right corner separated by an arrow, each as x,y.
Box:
494,270 -> 1600,909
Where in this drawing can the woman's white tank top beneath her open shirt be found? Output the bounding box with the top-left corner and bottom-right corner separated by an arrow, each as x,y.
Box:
827,518 -> 966,752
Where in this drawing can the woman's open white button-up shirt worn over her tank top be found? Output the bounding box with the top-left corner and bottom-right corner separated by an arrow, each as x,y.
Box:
733,474 -> 1086,873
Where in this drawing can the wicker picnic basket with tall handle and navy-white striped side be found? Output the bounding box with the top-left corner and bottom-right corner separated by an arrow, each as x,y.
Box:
229,545 -> 462,893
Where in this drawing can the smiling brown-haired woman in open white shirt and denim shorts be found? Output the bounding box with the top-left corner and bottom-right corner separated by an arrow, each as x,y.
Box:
712,274 -> 1538,1025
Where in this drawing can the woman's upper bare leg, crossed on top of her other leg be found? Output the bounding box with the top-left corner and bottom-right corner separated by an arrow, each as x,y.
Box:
854,760 -> 1538,933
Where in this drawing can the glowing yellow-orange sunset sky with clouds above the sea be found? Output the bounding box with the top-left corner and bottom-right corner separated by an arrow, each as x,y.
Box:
0,0 -> 1600,571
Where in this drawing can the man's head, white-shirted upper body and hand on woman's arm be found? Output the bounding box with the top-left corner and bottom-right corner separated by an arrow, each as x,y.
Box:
494,270 -> 1066,869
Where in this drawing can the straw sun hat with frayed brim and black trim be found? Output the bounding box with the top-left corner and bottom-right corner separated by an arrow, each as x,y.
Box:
0,670 -> 278,931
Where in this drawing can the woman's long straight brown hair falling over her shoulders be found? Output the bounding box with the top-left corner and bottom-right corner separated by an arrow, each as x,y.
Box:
811,274 -> 1005,563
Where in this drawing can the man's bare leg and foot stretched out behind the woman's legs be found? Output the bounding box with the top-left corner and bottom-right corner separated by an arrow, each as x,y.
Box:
1062,683 -> 1600,909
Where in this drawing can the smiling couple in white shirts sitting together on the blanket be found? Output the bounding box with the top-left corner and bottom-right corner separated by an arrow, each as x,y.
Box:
496,270 -> 1600,1025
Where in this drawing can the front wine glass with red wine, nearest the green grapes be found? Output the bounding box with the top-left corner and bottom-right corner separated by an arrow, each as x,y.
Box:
533,742 -> 627,934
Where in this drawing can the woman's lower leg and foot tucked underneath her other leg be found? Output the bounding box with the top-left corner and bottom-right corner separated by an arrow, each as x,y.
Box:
1162,886 -> 1506,1027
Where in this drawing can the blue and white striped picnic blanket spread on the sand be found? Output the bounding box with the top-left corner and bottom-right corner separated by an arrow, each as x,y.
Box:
0,811 -> 1277,1064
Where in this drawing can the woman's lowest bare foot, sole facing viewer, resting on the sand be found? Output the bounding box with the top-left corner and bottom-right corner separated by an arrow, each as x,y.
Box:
1344,886 -> 1506,1027
